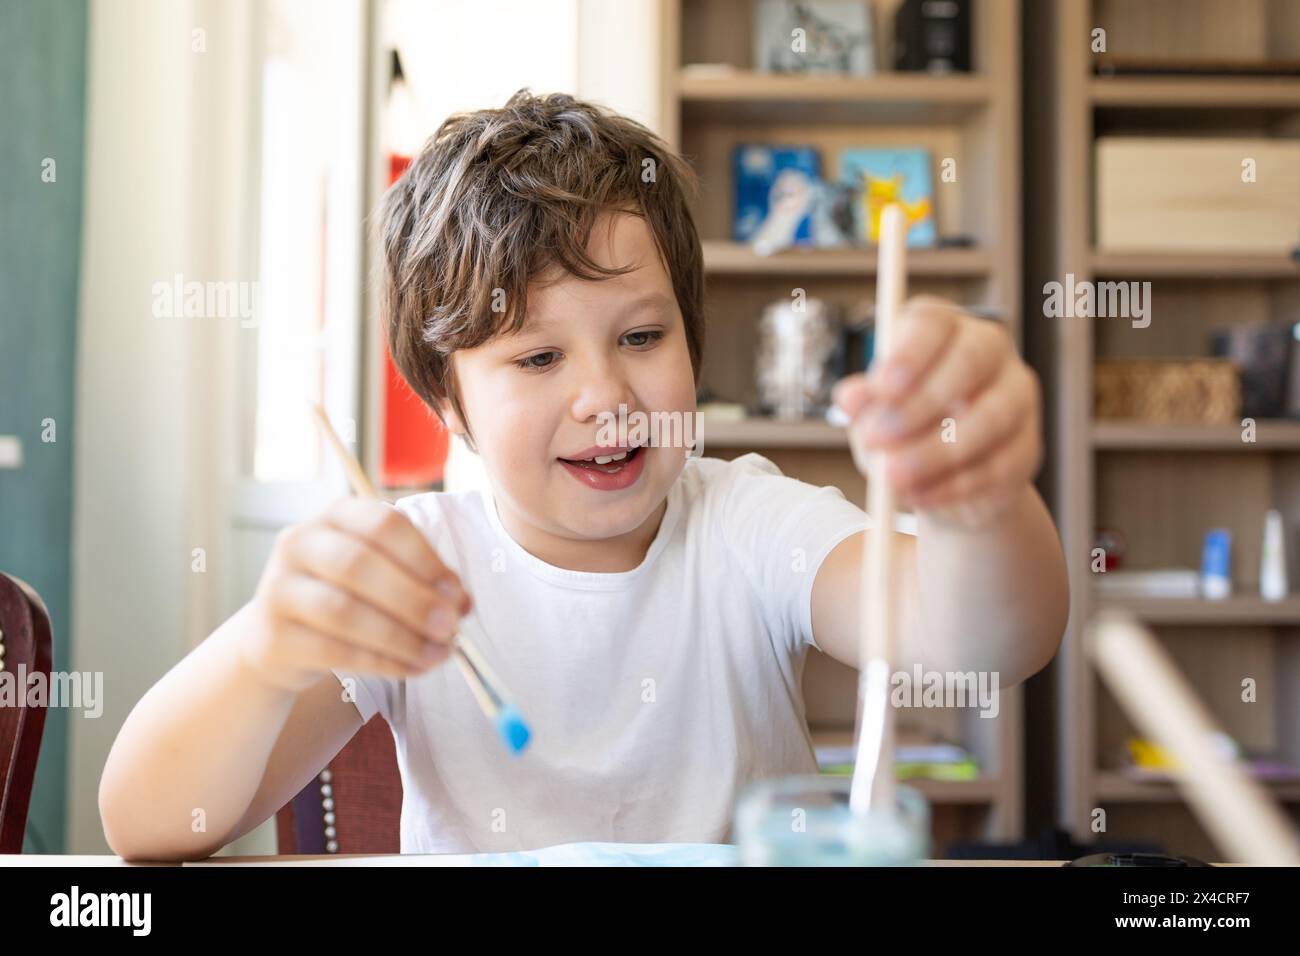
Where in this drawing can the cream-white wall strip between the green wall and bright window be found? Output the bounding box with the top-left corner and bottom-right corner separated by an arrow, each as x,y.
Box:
66,0 -> 250,853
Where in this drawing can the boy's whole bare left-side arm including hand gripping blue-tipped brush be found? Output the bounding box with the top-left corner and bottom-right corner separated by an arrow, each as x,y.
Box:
99,498 -> 469,860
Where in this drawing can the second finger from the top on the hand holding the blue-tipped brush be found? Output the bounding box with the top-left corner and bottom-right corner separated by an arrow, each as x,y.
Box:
286,524 -> 460,640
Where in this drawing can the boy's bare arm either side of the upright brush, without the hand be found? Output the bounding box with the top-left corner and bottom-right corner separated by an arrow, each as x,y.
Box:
813,484 -> 1069,687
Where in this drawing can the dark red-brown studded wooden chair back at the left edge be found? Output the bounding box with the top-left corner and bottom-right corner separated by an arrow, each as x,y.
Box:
0,572 -> 55,853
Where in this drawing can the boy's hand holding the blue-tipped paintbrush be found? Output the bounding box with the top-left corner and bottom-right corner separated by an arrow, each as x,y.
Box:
242,498 -> 471,692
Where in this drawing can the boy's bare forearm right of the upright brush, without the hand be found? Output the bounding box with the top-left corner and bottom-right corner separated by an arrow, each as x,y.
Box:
917,483 -> 1070,687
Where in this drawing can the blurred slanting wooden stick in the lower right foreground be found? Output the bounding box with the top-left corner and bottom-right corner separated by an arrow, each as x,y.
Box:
1087,609 -> 1300,866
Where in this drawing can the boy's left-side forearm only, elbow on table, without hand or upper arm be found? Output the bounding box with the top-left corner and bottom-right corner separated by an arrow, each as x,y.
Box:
99,606 -> 296,860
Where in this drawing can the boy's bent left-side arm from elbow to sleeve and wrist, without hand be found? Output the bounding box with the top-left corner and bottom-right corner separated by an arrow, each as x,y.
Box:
99,606 -> 361,860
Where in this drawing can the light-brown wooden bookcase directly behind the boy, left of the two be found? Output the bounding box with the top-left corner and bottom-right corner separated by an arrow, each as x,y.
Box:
659,0 -> 1024,847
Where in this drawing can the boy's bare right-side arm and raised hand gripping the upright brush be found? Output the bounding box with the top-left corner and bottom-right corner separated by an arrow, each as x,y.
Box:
814,297 -> 1070,685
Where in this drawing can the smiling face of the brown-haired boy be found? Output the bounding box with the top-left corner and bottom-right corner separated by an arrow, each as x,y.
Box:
449,213 -> 696,563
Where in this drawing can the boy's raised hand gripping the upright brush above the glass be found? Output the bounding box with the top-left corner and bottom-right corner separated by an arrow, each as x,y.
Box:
835,297 -> 1043,529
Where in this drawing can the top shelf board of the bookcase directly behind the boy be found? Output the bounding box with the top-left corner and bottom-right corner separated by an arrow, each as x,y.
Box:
677,68 -> 989,124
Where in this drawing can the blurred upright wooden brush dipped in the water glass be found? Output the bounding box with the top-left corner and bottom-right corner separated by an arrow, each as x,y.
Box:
849,204 -> 907,814
